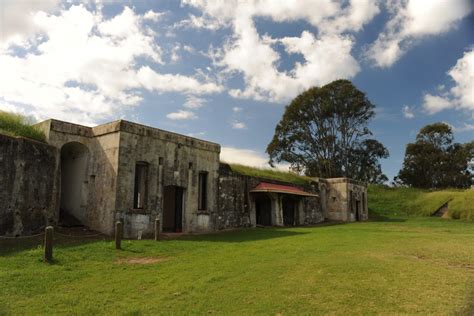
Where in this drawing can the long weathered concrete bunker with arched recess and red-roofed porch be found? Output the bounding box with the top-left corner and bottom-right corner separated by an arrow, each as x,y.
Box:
0,120 -> 368,238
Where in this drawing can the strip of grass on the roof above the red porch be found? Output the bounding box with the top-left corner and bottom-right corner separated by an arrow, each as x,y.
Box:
225,164 -> 311,185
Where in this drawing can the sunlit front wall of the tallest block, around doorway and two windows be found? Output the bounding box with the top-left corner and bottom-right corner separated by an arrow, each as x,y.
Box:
116,121 -> 220,238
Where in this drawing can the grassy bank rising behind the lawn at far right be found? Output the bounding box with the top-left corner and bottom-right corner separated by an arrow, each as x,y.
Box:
367,185 -> 474,221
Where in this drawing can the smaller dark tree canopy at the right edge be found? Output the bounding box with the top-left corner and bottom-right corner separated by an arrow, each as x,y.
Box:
395,123 -> 473,189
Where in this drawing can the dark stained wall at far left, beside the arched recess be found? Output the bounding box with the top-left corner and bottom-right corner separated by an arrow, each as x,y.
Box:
0,134 -> 59,236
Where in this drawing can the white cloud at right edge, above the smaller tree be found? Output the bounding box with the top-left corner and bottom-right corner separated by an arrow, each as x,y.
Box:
423,49 -> 474,114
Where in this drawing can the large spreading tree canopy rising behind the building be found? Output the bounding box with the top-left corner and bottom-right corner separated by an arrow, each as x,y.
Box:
266,80 -> 389,183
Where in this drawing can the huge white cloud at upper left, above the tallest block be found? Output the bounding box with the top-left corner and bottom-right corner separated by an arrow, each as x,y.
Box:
0,5 -> 222,124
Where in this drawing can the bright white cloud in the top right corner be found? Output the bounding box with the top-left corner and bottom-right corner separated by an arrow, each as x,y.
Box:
366,0 -> 473,67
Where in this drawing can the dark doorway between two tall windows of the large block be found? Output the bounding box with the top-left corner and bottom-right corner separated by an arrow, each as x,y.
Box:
163,186 -> 184,233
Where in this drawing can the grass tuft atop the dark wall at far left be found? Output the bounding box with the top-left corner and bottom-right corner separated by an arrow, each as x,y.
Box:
0,111 -> 46,142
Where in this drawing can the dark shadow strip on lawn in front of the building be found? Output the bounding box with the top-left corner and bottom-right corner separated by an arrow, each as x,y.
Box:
177,227 -> 308,243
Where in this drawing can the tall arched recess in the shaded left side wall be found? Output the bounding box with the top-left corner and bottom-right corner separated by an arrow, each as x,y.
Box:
59,142 -> 89,226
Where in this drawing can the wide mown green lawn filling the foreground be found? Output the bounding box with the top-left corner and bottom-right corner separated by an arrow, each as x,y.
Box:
0,218 -> 474,315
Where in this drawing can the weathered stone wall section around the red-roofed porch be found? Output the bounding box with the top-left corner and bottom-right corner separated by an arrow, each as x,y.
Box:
216,163 -> 324,230
